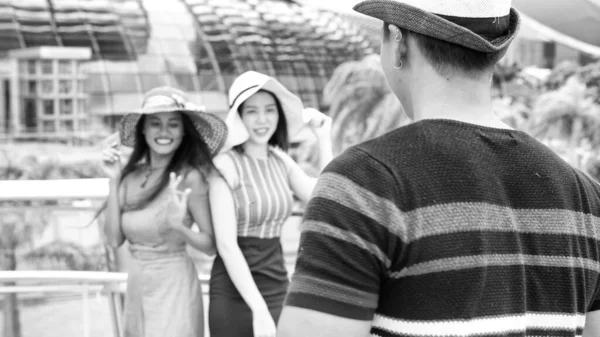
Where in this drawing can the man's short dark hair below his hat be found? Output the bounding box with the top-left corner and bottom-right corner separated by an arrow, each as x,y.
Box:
383,22 -> 507,77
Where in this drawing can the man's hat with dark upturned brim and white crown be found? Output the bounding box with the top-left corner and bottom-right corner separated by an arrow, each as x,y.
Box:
354,0 -> 521,53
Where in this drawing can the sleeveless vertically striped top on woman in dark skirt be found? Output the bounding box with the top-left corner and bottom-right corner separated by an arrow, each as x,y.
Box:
228,148 -> 293,239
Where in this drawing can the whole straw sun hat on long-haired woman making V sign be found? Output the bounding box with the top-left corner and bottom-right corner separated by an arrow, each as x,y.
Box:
119,87 -> 228,156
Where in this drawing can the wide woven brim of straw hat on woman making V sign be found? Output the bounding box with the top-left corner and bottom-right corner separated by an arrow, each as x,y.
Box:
119,108 -> 228,157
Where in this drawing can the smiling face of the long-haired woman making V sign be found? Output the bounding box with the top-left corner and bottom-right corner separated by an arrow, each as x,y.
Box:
144,112 -> 185,155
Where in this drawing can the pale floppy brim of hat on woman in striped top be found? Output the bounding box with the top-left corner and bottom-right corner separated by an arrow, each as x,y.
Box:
225,78 -> 304,148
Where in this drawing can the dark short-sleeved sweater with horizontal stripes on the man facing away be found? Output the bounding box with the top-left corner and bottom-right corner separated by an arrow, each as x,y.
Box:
286,120 -> 600,337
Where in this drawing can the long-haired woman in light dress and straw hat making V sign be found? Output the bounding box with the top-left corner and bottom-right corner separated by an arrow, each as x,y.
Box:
102,87 -> 227,337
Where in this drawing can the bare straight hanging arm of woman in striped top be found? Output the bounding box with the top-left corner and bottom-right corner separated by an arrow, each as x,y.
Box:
209,156 -> 269,314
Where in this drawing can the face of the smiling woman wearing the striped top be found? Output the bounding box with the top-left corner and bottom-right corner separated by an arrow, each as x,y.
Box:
241,92 -> 279,144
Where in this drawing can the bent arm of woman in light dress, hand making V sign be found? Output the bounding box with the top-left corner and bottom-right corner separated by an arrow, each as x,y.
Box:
172,170 -> 217,255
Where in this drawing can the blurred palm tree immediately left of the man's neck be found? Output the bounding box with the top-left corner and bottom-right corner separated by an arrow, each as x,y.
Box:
323,55 -> 410,154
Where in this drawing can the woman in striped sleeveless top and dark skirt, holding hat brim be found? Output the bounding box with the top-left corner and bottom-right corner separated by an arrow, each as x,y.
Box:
209,71 -> 331,337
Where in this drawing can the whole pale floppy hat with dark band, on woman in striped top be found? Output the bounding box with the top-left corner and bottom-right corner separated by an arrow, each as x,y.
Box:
225,71 -> 304,148
